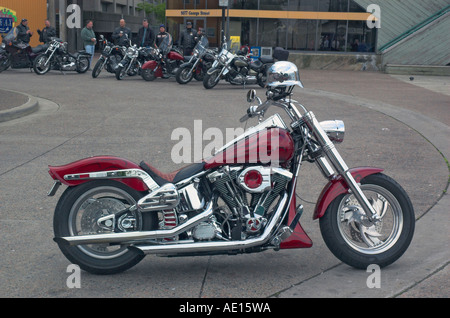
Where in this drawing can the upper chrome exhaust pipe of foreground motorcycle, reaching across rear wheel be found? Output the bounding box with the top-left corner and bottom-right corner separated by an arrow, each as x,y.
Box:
53,200 -> 214,245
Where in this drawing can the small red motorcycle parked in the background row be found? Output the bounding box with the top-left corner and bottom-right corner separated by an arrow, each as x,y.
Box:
141,35 -> 184,81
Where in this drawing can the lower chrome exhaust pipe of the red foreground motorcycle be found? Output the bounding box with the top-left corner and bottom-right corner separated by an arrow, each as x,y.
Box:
128,193 -> 288,255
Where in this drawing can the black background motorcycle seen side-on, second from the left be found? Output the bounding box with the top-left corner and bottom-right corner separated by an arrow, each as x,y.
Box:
33,38 -> 91,75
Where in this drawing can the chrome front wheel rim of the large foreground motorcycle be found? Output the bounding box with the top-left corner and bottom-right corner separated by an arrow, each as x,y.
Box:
337,184 -> 403,254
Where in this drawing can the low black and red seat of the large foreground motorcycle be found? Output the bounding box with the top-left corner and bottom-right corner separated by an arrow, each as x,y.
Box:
139,161 -> 206,186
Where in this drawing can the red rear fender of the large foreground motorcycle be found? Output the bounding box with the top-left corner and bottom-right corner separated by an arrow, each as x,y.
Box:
48,156 -> 148,191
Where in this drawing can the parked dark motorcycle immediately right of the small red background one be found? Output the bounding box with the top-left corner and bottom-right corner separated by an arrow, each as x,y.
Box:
175,36 -> 215,84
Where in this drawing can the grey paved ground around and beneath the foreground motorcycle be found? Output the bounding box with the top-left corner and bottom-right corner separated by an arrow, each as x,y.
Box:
0,63 -> 450,298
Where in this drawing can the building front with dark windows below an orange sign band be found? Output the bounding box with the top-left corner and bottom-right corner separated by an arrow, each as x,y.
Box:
166,0 -> 377,52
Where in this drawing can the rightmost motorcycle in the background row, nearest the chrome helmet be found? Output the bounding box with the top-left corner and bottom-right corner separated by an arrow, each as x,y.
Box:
203,41 -> 274,89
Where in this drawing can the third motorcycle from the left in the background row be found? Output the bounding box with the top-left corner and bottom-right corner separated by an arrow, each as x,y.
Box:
92,35 -> 127,78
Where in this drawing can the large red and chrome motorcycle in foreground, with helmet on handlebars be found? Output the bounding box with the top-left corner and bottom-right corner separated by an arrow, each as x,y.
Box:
49,62 -> 415,274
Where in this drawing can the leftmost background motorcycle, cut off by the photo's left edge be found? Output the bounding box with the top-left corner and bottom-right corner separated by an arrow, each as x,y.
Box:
0,28 -> 48,73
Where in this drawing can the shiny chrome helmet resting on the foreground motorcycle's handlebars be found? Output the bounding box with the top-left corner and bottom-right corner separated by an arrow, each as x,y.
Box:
267,61 -> 303,88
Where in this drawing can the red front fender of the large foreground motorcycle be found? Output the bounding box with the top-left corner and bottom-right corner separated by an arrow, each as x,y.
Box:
313,167 -> 383,220
